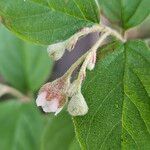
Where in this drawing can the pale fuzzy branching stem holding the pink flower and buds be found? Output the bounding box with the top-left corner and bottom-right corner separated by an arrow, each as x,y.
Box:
58,24 -> 126,85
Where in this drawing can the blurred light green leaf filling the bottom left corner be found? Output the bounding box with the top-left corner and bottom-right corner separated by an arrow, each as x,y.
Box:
0,100 -> 46,150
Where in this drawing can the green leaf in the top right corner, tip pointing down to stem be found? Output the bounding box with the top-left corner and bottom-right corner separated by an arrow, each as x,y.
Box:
98,0 -> 150,29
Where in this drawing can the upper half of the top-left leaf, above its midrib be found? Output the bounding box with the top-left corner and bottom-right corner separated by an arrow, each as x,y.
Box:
30,0 -> 99,23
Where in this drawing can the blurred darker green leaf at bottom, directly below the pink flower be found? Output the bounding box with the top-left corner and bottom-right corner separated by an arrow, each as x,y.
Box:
42,110 -> 75,150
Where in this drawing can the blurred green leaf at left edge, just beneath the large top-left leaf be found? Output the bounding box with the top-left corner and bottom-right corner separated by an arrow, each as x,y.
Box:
0,26 -> 52,92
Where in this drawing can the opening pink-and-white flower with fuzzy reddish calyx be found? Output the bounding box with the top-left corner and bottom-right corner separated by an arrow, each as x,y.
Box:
36,78 -> 68,115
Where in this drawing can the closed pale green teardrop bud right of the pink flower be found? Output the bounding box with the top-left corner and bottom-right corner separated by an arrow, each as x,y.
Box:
67,91 -> 88,116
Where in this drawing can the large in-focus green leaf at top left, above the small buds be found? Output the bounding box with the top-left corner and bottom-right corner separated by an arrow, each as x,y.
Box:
0,0 -> 98,45
